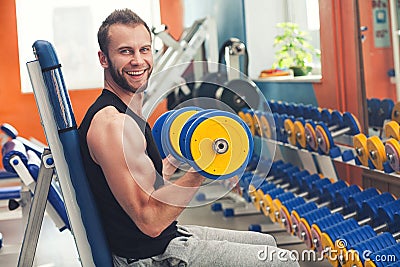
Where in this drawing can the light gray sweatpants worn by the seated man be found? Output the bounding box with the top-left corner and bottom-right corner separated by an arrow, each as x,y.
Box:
113,226 -> 299,267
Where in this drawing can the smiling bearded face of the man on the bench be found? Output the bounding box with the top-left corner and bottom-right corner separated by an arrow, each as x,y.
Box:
106,24 -> 153,93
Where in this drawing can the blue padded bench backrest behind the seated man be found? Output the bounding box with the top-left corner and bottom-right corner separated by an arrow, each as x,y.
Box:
33,40 -> 112,266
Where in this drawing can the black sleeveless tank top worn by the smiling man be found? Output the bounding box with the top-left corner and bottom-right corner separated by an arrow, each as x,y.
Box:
78,89 -> 177,259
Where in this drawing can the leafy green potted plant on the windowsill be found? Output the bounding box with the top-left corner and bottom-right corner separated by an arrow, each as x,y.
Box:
272,22 -> 321,76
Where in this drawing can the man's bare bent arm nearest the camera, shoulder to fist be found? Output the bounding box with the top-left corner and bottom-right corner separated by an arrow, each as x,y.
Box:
87,107 -> 204,237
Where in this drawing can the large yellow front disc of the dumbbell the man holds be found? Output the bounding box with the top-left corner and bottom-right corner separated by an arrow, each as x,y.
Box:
190,116 -> 250,176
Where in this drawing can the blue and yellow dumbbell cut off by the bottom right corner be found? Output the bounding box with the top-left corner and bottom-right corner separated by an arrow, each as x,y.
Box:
364,243 -> 400,267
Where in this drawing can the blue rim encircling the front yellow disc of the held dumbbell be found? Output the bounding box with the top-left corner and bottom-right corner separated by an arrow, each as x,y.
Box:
184,111 -> 254,180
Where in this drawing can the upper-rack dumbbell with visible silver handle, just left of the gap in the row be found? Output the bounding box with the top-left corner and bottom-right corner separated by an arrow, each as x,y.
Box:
315,112 -> 361,154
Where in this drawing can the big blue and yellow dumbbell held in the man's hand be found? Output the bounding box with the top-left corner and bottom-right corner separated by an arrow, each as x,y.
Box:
152,107 -> 254,179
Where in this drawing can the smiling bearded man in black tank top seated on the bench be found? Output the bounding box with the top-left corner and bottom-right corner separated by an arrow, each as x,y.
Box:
79,9 -> 298,266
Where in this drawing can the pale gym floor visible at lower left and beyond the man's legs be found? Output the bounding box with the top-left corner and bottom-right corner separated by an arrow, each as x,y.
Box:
0,183 -> 331,267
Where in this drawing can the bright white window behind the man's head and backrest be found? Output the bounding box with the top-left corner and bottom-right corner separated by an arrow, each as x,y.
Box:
16,0 -> 160,92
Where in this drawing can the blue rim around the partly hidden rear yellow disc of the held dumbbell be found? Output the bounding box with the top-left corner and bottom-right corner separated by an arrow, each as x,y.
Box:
161,106 -> 203,162
